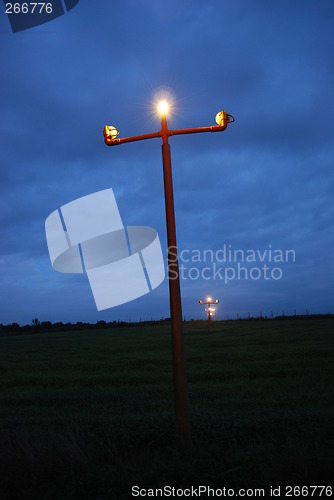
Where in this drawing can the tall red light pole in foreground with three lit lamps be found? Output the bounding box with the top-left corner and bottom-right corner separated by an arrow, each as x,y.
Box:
103,101 -> 234,444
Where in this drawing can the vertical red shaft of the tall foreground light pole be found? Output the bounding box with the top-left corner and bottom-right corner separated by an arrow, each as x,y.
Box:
162,117 -> 190,444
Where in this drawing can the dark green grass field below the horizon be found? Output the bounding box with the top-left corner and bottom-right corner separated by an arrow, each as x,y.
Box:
0,319 -> 334,500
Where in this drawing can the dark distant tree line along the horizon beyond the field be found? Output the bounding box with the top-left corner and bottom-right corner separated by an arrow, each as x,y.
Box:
0,313 -> 334,336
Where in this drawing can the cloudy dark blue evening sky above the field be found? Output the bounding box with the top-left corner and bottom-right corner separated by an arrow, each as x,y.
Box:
0,0 -> 334,324
